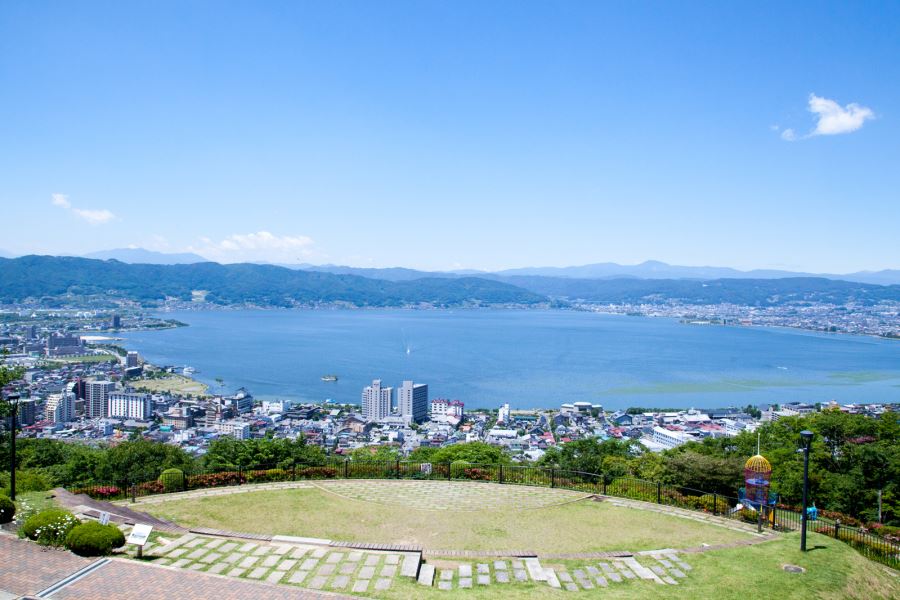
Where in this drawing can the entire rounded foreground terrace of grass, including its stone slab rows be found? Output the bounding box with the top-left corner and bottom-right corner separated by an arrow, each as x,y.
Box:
123,480 -> 900,599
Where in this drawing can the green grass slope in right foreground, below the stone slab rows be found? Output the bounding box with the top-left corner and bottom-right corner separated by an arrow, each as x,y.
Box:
376,534 -> 900,600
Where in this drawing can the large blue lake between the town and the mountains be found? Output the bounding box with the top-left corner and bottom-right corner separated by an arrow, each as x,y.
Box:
119,310 -> 900,409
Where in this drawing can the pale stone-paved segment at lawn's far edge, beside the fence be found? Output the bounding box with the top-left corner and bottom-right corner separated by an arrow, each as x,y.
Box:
315,479 -> 588,510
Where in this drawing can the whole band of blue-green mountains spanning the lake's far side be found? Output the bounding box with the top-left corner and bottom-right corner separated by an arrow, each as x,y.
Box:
0,256 -> 900,307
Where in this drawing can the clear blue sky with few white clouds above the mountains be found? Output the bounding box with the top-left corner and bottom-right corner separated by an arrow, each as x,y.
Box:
0,1 -> 900,272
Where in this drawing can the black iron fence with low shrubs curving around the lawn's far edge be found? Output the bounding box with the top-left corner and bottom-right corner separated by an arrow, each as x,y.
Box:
70,458 -> 900,569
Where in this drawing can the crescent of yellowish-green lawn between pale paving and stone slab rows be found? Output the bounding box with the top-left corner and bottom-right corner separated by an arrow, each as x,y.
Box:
140,482 -> 750,553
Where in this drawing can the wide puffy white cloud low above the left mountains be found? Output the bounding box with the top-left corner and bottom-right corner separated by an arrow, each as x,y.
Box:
188,231 -> 315,263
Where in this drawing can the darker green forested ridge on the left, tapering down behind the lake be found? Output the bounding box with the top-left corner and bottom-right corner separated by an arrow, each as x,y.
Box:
0,256 -> 547,307
